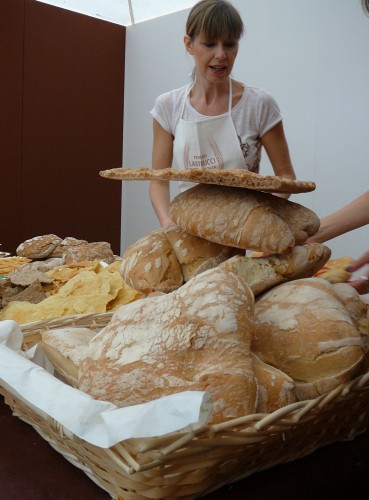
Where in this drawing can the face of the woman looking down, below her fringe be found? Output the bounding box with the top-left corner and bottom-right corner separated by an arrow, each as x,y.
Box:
184,34 -> 238,83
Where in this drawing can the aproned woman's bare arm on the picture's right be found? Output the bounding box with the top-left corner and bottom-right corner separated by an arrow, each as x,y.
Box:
261,122 -> 296,198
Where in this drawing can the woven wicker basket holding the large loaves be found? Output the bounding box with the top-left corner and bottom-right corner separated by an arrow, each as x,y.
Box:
0,313 -> 369,500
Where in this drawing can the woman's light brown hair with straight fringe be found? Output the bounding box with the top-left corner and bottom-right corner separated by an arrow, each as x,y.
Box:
186,0 -> 244,41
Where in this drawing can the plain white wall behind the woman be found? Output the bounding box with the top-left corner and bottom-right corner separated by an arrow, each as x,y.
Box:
122,0 -> 369,264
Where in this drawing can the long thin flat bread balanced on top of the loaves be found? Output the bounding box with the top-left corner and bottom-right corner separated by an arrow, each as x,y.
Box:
99,167 -> 316,194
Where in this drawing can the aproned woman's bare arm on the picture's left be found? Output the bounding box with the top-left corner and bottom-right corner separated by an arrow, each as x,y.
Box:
149,119 -> 174,227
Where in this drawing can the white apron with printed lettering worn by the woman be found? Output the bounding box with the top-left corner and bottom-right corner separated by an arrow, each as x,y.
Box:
172,79 -> 246,192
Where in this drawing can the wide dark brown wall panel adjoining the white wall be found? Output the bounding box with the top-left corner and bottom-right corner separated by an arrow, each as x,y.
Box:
0,0 -> 125,253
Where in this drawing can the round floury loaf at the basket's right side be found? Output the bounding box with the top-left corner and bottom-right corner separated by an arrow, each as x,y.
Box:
252,278 -> 364,399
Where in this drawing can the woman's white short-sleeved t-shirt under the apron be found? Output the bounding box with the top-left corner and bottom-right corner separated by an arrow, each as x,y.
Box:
151,84 -> 282,172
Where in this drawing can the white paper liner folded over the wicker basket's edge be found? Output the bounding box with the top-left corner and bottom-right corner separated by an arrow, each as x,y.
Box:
0,320 -> 211,448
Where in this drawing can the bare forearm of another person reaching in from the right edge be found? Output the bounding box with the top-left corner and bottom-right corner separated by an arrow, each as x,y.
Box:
307,191 -> 369,243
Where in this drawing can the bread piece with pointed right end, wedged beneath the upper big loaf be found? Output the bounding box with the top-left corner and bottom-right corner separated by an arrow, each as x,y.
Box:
220,243 -> 331,296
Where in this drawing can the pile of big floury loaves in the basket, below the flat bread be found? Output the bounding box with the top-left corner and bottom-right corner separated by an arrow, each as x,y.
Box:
43,172 -> 369,423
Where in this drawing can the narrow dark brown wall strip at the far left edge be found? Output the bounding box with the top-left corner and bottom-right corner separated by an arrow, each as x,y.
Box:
0,0 -> 24,251
